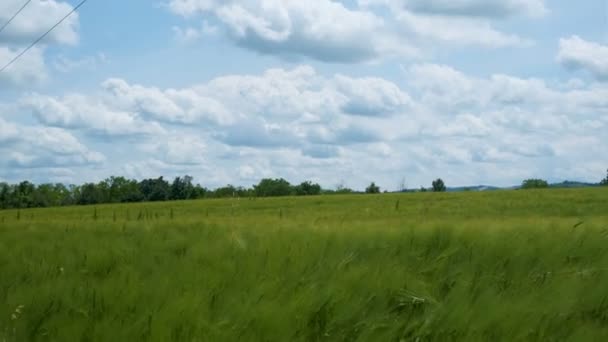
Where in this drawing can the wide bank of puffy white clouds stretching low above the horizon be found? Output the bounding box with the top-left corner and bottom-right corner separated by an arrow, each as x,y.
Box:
8,64 -> 608,186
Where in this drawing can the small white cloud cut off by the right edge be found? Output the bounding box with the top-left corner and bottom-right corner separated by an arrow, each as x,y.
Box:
557,36 -> 608,81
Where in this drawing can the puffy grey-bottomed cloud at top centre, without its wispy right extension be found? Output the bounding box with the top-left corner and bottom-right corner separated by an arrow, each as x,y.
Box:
168,0 -> 417,63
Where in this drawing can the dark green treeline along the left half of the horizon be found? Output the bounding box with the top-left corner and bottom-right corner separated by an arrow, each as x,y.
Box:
0,176 -> 332,209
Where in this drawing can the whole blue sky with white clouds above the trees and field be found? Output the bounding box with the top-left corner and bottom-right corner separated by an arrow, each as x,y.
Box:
0,0 -> 608,190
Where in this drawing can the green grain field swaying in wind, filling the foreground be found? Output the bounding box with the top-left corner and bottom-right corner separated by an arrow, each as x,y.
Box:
0,189 -> 608,342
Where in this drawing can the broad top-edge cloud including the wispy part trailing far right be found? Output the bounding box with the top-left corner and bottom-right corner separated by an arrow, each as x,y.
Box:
167,0 -> 548,63
